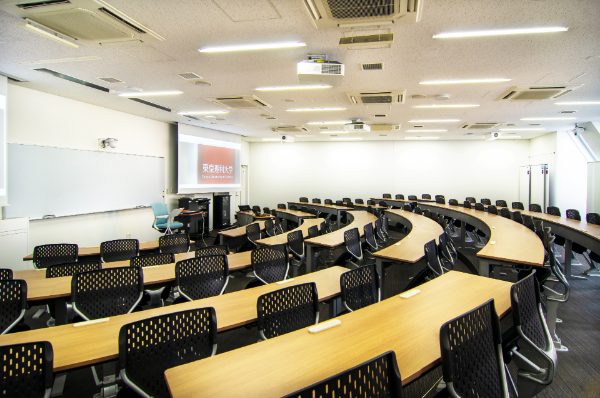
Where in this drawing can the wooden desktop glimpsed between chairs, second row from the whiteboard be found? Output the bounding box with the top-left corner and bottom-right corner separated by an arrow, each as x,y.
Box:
13,251 -> 251,301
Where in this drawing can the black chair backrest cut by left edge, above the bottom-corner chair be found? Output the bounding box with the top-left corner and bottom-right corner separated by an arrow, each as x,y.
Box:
0,279 -> 27,336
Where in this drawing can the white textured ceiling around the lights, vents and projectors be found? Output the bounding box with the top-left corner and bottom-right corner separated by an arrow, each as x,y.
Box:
0,0 -> 600,140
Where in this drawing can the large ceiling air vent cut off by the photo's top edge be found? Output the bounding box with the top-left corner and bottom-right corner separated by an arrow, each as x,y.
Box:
304,0 -> 421,28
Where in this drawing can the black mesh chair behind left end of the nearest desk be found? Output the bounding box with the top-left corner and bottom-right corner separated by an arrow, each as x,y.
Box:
119,307 -> 217,398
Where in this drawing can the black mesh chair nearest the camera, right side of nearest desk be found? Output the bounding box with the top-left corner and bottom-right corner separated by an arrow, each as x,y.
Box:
440,300 -> 508,397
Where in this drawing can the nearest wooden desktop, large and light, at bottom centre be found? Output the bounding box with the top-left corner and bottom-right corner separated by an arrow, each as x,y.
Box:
165,271 -> 511,398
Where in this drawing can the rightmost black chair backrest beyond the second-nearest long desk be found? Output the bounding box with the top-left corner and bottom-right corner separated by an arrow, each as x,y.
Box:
250,245 -> 289,284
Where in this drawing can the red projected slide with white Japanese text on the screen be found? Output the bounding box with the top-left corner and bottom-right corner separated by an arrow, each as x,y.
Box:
198,145 -> 235,184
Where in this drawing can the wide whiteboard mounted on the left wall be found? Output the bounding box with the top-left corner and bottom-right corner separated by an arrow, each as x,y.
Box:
5,144 -> 165,219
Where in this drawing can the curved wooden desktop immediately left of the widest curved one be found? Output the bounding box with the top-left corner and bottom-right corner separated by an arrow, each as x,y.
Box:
373,209 -> 444,263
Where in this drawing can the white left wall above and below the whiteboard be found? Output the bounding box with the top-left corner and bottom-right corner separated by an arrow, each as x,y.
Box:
7,84 -> 171,254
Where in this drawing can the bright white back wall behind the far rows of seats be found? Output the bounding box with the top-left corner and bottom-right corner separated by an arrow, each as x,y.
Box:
250,140 -> 529,207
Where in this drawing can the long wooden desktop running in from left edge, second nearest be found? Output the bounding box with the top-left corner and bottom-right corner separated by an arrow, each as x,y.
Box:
0,266 -> 348,372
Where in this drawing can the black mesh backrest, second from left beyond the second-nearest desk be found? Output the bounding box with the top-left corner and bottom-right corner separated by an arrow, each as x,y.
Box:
71,267 -> 144,320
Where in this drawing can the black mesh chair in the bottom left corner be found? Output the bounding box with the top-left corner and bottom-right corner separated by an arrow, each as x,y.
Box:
0,341 -> 54,398
